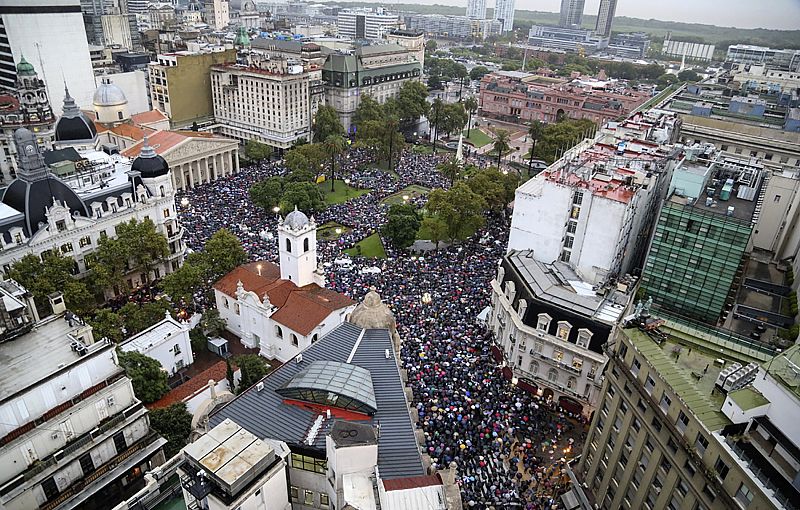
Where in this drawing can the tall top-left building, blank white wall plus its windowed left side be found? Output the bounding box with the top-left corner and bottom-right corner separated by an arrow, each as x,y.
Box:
0,0 -> 95,115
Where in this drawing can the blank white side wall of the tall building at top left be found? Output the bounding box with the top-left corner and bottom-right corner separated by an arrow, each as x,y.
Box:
3,0 -> 96,115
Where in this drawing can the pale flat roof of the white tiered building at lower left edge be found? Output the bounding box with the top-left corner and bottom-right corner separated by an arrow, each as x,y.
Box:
0,317 -> 110,399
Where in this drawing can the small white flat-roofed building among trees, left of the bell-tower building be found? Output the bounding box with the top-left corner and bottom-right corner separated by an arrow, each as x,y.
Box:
120,312 -> 194,376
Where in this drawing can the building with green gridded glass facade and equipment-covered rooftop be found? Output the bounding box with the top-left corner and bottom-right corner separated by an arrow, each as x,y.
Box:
642,153 -> 766,324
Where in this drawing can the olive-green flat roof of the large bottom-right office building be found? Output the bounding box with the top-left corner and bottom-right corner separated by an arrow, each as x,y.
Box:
621,328 -> 736,431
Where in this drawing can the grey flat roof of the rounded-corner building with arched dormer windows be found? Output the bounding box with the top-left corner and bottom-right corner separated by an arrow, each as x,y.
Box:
508,250 -> 632,324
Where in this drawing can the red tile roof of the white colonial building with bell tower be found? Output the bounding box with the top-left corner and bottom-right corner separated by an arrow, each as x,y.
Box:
214,262 -> 355,336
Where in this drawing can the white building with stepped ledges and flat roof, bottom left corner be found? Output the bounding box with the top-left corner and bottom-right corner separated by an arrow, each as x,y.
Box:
0,298 -> 166,510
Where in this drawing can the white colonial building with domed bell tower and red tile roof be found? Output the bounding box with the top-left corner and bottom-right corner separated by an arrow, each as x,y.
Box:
214,210 -> 355,362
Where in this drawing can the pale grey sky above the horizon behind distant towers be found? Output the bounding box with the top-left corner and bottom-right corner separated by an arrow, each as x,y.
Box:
374,0 -> 800,30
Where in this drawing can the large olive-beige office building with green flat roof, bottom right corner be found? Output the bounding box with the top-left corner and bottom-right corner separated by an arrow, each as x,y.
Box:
576,322 -> 800,510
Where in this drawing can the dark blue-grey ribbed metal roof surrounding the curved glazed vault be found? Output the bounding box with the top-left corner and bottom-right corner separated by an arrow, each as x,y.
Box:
209,323 -> 425,479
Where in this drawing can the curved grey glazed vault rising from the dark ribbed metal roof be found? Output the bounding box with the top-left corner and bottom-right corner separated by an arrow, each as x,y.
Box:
276,361 -> 378,415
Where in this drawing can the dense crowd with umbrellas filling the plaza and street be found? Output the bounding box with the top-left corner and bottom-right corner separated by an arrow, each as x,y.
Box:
179,151 -> 584,509
